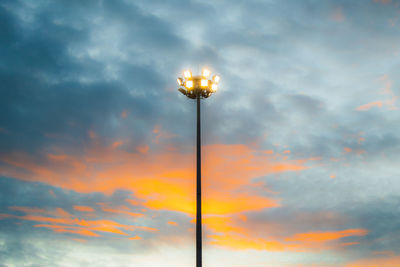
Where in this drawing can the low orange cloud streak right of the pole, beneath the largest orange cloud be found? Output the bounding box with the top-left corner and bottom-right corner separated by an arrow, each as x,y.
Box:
202,211 -> 368,251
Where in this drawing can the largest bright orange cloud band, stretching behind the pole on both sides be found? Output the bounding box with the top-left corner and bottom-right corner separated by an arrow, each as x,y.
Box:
0,143 -> 310,217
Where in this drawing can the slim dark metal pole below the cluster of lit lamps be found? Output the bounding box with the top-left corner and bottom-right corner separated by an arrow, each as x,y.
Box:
196,93 -> 202,267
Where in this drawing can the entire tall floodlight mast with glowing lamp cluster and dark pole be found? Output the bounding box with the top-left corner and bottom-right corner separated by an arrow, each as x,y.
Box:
177,69 -> 220,267
